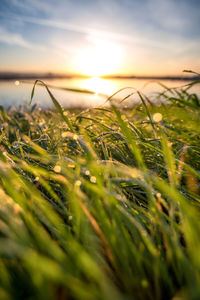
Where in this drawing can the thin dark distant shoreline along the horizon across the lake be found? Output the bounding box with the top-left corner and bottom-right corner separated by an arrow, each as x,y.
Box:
0,72 -> 200,81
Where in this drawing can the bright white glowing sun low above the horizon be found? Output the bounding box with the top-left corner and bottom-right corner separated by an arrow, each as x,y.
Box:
75,38 -> 122,77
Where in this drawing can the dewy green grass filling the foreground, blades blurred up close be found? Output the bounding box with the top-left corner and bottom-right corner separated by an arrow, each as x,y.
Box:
0,75 -> 200,300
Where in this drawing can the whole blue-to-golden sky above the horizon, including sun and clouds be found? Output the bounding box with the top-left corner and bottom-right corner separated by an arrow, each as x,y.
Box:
0,0 -> 200,76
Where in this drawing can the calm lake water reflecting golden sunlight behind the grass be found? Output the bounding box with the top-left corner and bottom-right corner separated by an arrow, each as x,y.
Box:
0,78 -> 200,108
